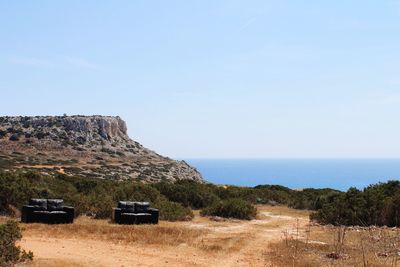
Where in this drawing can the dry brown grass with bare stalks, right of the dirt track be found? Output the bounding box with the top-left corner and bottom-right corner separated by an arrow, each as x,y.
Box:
265,226 -> 400,267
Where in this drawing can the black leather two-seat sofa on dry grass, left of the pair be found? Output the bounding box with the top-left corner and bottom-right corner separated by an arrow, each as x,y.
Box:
21,198 -> 74,224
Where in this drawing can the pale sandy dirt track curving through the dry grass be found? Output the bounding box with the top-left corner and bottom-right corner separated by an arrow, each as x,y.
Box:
20,206 -> 308,267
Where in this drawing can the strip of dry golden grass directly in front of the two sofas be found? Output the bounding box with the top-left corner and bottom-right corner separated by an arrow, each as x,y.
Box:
21,217 -> 206,246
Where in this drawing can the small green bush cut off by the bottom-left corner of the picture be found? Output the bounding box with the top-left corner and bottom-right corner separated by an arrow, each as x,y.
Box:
0,220 -> 33,266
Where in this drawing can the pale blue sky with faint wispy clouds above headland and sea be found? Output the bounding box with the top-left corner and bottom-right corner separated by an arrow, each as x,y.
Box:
0,0 -> 400,158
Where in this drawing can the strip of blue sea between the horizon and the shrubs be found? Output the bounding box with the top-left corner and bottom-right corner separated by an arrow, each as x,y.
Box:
186,159 -> 400,190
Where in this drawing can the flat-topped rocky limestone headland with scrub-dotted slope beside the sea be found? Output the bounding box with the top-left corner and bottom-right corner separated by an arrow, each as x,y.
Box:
0,116 -> 203,182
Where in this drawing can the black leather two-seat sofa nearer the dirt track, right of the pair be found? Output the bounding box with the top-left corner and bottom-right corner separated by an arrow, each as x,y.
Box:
114,201 -> 159,224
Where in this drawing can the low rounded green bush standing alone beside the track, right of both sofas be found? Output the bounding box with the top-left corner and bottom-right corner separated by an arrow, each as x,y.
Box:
201,198 -> 257,220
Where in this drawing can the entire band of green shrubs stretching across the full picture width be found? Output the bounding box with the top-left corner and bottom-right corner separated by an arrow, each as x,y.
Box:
0,171 -> 400,226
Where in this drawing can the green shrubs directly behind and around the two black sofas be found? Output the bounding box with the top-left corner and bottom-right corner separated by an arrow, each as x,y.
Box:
0,172 -> 193,221
